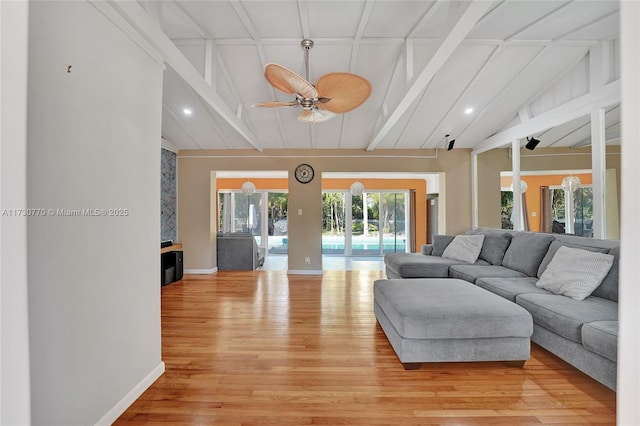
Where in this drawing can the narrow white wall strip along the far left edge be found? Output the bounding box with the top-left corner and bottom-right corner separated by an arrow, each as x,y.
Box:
0,2 -> 30,425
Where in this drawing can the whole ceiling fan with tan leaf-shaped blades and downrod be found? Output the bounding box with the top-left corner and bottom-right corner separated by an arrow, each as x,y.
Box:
252,39 -> 371,123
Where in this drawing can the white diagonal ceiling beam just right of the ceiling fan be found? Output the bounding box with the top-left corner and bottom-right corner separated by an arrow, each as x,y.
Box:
367,0 -> 491,151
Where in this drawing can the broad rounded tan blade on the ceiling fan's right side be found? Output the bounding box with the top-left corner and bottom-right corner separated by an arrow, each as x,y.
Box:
316,72 -> 371,114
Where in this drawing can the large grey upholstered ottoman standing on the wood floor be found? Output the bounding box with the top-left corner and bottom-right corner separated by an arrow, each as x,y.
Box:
373,278 -> 533,369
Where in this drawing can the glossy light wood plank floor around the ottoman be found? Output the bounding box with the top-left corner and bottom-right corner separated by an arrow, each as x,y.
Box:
116,271 -> 615,425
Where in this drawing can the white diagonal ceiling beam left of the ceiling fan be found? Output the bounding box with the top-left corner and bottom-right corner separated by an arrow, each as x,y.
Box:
109,2 -> 263,152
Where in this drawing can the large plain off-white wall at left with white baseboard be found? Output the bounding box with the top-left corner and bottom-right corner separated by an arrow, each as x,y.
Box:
27,2 -> 163,425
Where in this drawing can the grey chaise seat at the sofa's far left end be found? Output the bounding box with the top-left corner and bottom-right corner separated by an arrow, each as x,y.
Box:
384,253 -> 462,278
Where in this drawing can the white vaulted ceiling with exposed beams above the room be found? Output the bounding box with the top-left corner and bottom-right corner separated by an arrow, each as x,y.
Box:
130,0 -> 620,151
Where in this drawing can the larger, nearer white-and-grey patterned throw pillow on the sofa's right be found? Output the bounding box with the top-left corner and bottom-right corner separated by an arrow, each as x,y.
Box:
536,246 -> 613,300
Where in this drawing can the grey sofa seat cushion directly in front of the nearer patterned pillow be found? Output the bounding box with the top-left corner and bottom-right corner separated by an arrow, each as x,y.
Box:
516,293 -> 618,344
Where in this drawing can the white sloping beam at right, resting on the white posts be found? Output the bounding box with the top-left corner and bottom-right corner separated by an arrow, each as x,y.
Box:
473,80 -> 621,154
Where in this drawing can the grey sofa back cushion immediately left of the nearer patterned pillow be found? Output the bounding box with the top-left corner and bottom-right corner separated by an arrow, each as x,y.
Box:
502,232 -> 554,277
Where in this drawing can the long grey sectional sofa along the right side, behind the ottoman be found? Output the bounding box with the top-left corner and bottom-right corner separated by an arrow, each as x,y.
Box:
385,228 -> 620,390
